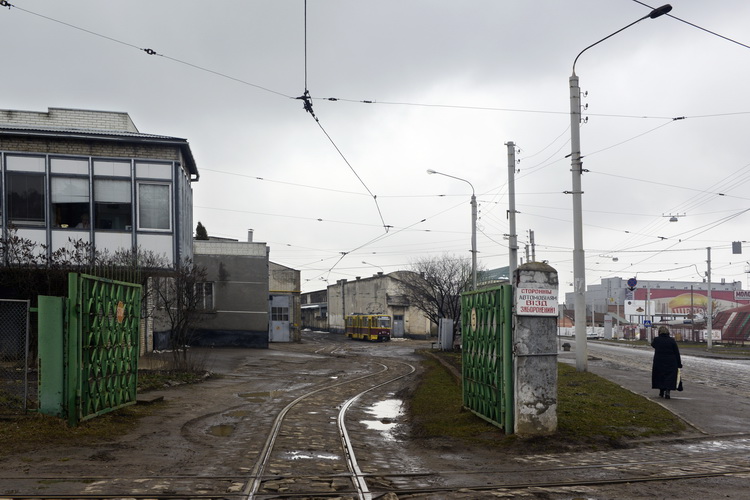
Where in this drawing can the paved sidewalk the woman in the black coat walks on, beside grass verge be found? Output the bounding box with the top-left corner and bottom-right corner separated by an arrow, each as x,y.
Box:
558,346 -> 750,436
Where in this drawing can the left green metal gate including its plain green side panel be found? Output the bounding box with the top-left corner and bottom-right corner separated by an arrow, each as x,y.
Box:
39,273 -> 141,426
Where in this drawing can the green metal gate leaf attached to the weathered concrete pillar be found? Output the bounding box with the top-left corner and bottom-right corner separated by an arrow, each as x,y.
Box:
461,285 -> 513,433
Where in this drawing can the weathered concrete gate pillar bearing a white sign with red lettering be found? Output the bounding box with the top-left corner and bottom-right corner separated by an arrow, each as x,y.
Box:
513,262 -> 558,436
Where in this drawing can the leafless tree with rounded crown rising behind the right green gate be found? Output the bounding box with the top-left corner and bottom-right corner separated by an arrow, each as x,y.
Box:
390,254 -> 471,332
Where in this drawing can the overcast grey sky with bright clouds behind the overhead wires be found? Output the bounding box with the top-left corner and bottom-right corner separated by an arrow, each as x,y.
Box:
0,0 -> 750,293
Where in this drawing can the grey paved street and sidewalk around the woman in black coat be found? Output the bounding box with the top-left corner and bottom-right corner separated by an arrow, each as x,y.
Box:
560,339 -> 750,435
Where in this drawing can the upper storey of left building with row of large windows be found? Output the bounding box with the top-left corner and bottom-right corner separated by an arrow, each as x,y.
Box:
0,108 -> 199,267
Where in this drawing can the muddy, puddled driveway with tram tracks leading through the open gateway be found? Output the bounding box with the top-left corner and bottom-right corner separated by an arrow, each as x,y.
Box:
0,333 -> 750,499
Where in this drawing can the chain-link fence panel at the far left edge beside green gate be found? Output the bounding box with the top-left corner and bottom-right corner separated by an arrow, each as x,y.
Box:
0,299 -> 37,415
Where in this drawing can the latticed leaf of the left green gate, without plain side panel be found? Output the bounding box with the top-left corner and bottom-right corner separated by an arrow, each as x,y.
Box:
75,274 -> 141,421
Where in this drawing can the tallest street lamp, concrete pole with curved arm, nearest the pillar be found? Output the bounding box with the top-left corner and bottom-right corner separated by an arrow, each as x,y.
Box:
566,4 -> 672,371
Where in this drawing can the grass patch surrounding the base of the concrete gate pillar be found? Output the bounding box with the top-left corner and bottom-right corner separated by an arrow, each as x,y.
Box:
409,353 -> 686,453
